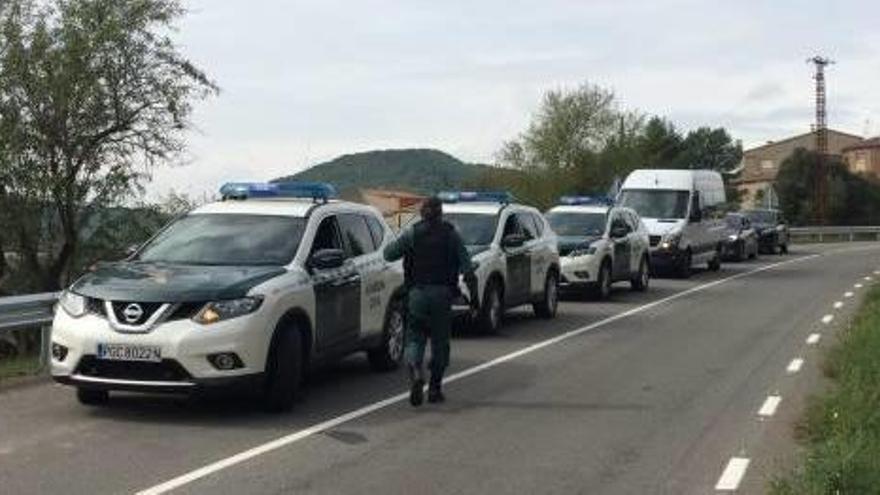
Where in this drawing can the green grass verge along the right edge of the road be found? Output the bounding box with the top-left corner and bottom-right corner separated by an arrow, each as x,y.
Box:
769,287 -> 880,495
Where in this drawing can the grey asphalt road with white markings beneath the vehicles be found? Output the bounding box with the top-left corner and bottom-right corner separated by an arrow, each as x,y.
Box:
0,244 -> 880,495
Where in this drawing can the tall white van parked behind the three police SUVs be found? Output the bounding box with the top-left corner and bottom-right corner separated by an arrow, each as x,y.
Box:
617,169 -> 726,278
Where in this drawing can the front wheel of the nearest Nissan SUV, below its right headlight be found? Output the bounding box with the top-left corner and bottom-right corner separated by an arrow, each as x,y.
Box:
263,327 -> 303,412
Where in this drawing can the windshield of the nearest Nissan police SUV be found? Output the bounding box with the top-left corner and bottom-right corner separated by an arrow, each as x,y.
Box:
138,214 -> 305,265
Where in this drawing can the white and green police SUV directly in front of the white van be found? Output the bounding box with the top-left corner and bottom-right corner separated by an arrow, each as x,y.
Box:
546,196 -> 650,299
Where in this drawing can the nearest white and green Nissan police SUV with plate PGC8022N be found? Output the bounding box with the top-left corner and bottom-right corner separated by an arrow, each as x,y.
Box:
52,182 -> 403,410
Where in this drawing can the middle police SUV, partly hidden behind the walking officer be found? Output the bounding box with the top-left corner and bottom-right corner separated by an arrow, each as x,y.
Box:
440,192 -> 559,332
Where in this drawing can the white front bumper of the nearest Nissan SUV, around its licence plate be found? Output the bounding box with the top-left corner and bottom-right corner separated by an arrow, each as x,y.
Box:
51,309 -> 271,393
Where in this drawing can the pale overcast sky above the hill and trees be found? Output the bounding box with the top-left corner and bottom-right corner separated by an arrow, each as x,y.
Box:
149,0 -> 880,202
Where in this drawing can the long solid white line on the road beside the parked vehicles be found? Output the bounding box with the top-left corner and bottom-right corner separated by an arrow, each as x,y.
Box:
137,254 -> 821,495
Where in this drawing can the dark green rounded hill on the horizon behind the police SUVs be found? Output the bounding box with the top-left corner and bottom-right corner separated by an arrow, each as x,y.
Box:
275,149 -> 486,194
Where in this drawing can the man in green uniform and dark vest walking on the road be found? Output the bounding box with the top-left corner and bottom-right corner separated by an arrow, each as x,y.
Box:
384,198 -> 477,406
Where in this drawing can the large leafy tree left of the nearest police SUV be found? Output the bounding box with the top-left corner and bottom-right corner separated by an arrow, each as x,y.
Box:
0,0 -> 218,290
